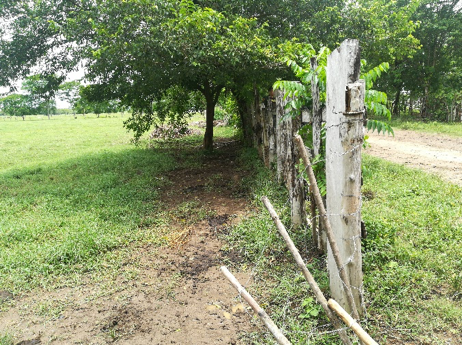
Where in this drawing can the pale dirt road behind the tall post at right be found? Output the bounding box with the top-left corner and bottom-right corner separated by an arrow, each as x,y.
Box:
364,130 -> 462,186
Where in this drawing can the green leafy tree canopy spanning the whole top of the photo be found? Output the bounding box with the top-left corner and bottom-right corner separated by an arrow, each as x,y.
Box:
0,0 -> 462,140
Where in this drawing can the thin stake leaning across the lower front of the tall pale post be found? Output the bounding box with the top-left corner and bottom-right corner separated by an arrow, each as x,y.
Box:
294,134 -> 359,320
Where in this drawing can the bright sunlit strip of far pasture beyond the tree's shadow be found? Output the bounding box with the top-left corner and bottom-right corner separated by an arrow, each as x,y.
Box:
0,115 -> 132,172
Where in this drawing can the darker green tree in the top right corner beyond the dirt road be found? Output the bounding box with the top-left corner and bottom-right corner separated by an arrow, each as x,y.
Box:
395,0 -> 462,120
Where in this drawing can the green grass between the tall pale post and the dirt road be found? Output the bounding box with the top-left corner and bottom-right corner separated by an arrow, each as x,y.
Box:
363,156 -> 462,344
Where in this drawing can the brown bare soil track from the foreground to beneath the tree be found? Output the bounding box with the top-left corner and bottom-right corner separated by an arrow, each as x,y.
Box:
0,143 -> 256,345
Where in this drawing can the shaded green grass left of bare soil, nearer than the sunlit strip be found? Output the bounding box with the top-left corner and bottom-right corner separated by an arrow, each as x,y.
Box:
0,140 -> 208,291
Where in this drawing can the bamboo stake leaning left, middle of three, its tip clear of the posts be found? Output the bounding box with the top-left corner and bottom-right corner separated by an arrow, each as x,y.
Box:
261,196 -> 351,345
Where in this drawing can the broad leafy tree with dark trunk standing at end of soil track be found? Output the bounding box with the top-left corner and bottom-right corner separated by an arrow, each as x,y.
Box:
76,0 -> 274,149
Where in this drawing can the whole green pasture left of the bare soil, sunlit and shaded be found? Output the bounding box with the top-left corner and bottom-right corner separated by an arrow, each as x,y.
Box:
0,117 -> 175,292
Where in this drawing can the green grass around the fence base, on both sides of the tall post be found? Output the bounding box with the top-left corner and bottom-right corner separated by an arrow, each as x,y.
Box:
226,147 -> 462,344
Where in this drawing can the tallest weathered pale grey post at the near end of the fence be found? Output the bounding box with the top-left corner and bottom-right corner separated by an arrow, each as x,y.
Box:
326,39 -> 365,315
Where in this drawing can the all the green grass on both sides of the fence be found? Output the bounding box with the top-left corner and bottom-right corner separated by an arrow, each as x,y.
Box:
0,115 -> 462,345
